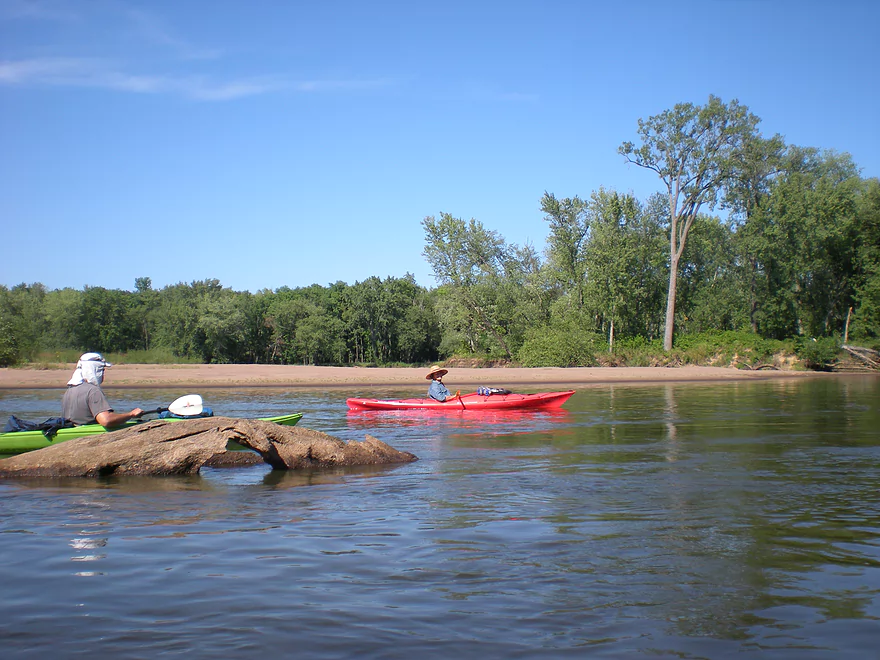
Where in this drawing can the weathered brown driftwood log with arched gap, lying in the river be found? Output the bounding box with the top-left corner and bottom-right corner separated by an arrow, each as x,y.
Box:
0,417 -> 418,477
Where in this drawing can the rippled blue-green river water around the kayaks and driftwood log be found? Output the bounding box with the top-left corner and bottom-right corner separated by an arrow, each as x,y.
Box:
0,376 -> 880,660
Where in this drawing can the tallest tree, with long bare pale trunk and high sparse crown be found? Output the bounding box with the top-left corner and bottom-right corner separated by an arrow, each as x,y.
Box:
619,96 -> 759,351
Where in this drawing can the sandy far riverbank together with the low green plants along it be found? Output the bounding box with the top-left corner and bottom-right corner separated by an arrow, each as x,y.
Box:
0,333 -> 880,390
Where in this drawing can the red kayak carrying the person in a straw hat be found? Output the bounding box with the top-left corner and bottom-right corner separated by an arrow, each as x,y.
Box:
346,390 -> 574,412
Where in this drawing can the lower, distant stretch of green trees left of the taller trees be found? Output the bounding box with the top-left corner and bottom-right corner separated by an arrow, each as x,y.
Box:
0,276 -> 440,365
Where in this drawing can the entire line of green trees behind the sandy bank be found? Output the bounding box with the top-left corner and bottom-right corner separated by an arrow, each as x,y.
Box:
0,97 -> 880,366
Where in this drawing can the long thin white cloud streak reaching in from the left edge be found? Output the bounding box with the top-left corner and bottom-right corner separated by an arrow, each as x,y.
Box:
0,58 -> 391,101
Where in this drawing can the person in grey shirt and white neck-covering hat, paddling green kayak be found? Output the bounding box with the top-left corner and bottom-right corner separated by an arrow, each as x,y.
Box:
61,353 -> 144,426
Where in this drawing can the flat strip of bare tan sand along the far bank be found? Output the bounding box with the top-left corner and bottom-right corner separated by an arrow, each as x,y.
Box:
0,364 -> 830,390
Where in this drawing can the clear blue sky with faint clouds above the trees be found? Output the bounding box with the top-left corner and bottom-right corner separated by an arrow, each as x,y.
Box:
0,0 -> 880,291
